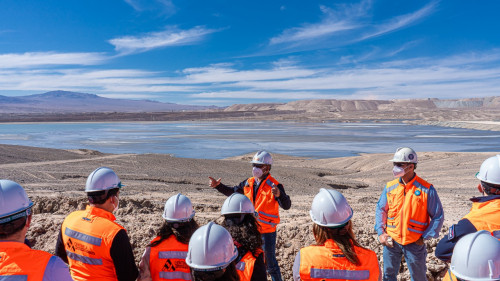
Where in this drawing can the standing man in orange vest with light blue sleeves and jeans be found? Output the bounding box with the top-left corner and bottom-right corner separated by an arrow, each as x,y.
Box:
375,147 -> 444,281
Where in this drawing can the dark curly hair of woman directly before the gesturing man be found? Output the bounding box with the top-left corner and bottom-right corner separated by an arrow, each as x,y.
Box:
222,214 -> 262,257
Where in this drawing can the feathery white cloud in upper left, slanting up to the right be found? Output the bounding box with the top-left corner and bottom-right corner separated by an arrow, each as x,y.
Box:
109,26 -> 217,55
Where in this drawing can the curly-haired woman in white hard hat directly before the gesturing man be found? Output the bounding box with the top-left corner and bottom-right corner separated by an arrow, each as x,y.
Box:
221,193 -> 267,281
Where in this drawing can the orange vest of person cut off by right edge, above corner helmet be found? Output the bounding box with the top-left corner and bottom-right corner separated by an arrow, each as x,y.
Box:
464,197 -> 500,236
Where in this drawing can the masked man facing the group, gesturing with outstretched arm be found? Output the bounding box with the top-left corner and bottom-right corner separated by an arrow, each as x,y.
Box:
209,150 -> 292,281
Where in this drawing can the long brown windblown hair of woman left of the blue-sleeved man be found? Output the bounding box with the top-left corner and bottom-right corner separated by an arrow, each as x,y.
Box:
313,221 -> 364,265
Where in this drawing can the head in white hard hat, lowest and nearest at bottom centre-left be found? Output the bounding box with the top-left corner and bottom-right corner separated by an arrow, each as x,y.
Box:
186,222 -> 242,281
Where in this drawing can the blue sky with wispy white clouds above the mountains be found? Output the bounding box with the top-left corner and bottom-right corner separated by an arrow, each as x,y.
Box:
0,0 -> 500,106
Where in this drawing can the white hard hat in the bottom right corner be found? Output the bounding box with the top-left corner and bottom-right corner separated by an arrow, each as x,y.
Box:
450,230 -> 500,281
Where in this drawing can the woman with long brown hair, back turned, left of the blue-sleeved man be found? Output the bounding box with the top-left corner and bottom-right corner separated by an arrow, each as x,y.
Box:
293,188 -> 382,281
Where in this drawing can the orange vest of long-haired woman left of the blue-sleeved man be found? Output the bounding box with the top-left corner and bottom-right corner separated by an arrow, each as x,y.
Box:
300,239 -> 380,281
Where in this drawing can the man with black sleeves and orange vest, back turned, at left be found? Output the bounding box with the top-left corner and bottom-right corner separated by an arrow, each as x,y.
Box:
56,167 -> 139,281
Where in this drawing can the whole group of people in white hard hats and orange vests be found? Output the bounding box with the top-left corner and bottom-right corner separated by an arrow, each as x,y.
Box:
0,147 -> 500,281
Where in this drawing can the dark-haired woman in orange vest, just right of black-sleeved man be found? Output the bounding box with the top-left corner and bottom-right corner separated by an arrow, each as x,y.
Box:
137,193 -> 198,281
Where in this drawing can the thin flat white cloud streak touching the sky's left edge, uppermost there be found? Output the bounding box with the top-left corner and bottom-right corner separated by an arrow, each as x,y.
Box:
0,52 -> 109,68
